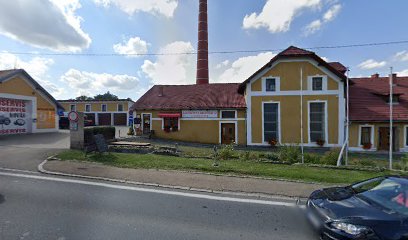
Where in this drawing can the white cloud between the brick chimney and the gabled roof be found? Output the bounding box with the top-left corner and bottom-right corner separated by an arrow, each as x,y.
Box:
215,52 -> 275,83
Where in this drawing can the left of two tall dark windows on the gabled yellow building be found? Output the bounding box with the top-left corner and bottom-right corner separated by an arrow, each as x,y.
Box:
263,103 -> 279,142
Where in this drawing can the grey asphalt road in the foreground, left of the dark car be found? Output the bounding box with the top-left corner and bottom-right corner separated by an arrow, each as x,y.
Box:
0,171 -> 317,240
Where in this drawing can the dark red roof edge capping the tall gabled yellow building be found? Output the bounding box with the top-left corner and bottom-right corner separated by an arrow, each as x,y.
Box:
238,46 -> 346,94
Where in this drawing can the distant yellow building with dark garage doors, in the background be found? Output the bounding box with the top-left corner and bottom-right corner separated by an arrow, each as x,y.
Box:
58,99 -> 134,128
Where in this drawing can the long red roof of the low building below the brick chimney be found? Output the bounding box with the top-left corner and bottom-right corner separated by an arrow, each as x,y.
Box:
132,83 -> 246,110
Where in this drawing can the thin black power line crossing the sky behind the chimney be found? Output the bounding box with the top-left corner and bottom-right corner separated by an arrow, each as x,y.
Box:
3,40 -> 408,57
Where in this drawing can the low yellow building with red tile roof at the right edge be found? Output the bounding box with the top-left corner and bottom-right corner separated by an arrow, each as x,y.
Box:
350,74 -> 408,152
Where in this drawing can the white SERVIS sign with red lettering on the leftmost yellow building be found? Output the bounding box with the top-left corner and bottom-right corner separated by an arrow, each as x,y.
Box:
0,98 -> 29,135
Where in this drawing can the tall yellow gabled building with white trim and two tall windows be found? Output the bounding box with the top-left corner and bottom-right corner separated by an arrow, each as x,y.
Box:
239,46 -> 346,147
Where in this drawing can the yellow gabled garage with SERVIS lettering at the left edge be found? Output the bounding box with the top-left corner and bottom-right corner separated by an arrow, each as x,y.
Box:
0,69 -> 63,135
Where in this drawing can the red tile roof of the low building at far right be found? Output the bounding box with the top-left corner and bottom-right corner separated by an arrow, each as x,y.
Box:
350,76 -> 408,122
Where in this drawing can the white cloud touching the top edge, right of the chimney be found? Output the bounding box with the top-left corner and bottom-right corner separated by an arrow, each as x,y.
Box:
243,0 -> 322,33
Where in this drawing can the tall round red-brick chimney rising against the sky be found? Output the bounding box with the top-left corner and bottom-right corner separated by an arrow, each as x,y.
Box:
196,0 -> 209,84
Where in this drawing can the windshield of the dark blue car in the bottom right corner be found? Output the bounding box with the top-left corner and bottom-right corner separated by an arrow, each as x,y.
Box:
351,177 -> 408,217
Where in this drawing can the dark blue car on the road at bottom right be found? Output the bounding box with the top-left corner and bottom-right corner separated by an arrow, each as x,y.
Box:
306,176 -> 408,240
